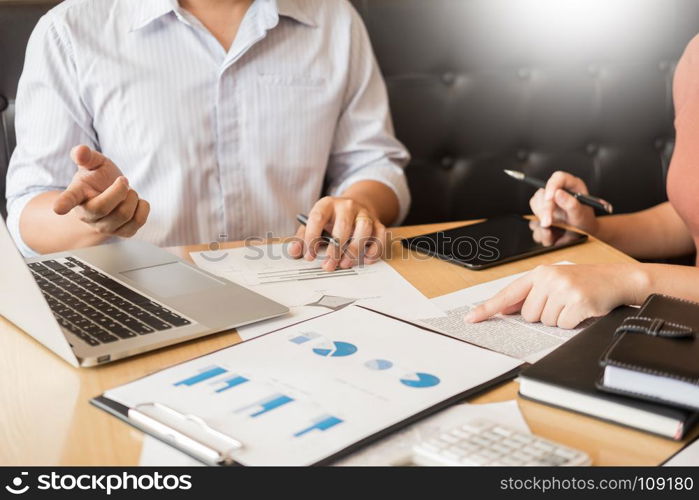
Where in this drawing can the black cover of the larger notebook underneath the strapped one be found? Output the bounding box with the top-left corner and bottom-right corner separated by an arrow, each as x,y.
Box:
521,307 -> 696,439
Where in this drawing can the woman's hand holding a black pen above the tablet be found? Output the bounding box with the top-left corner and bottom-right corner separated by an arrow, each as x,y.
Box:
529,171 -> 598,235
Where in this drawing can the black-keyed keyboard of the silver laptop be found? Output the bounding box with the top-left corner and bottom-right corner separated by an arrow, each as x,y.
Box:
29,257 -> 191,346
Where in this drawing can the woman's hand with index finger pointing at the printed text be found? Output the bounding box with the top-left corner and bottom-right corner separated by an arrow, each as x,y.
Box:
465,264 -> 649,328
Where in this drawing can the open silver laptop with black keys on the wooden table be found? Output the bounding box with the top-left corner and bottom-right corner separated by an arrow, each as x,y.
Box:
0,217 -> 288,367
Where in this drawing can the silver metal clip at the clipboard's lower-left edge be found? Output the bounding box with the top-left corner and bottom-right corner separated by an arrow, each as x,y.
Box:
128,402 -> 244,465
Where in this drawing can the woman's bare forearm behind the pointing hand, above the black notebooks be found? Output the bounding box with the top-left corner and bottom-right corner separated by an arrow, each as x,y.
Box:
630,264 -> 699,305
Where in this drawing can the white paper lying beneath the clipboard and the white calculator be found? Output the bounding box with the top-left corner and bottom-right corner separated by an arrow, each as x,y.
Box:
139,400 -> 530,467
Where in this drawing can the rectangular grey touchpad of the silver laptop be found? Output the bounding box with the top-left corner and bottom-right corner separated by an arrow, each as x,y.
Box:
121,262 -> 225,297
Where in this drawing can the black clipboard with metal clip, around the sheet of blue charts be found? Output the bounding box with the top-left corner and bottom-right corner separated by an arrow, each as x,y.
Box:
90,306 -> 522,466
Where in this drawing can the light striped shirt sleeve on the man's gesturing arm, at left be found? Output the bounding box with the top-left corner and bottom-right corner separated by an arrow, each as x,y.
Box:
7,13 -> 97,256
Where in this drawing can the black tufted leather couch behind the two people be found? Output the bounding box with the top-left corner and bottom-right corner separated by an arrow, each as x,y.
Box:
0,0 -> 699,223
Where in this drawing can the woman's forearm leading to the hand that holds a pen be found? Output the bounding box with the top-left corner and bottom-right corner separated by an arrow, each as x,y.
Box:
594,203 -> 695,259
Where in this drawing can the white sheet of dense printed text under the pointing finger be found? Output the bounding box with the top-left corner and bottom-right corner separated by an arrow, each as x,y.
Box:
420,262 -> 588,363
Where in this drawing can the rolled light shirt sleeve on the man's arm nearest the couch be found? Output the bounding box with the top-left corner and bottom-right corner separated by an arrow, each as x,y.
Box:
326,5 -> 410,224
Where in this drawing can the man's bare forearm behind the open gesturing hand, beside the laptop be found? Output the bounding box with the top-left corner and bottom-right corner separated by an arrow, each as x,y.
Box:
19,191 -> 109,254
